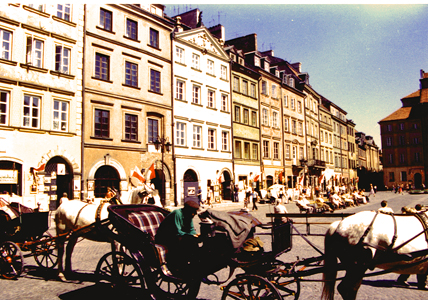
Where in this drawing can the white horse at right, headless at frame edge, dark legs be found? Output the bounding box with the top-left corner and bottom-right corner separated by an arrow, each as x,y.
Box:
321,211 -> 428,300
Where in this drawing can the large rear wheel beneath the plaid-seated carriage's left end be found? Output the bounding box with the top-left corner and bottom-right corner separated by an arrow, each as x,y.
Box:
95,252 -> 147,299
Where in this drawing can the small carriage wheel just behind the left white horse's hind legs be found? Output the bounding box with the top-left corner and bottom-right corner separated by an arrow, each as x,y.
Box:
33,235 -> 58,269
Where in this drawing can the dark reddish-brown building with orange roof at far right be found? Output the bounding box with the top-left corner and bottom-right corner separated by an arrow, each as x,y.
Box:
379,70 -> 428,188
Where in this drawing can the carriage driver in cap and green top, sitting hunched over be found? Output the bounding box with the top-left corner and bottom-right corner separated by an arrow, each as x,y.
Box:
155,200 -> 199,272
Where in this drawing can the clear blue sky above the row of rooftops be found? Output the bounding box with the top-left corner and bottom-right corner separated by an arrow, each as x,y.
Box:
163,2 -> 428,147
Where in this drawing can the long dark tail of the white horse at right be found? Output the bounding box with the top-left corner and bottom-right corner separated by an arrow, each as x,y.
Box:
321,221 -> 340,300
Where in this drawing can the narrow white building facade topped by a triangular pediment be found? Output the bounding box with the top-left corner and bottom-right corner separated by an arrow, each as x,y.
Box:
173,9 -> 234,203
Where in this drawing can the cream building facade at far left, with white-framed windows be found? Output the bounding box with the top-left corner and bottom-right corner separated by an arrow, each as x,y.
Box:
0,4 -> 84,210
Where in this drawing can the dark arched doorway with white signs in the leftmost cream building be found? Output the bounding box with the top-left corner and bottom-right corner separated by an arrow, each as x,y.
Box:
44,156 -> 74,210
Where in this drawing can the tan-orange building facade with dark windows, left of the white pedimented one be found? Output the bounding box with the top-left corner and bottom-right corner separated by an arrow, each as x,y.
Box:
82,4 -> 175,205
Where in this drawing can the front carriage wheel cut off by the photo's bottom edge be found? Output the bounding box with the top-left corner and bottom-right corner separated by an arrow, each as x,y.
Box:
221,275 -> 282,300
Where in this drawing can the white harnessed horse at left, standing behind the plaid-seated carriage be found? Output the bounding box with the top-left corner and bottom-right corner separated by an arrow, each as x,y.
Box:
55,185 -> 162,280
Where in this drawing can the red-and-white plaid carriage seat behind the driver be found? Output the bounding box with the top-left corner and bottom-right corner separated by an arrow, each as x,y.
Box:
128,211 -> 172,275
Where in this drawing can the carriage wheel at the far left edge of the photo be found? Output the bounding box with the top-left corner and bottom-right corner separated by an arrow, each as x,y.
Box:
0,242 -> 24,279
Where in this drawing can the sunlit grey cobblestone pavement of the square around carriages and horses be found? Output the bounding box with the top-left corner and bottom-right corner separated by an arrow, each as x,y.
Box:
0,192 -> 428,300
